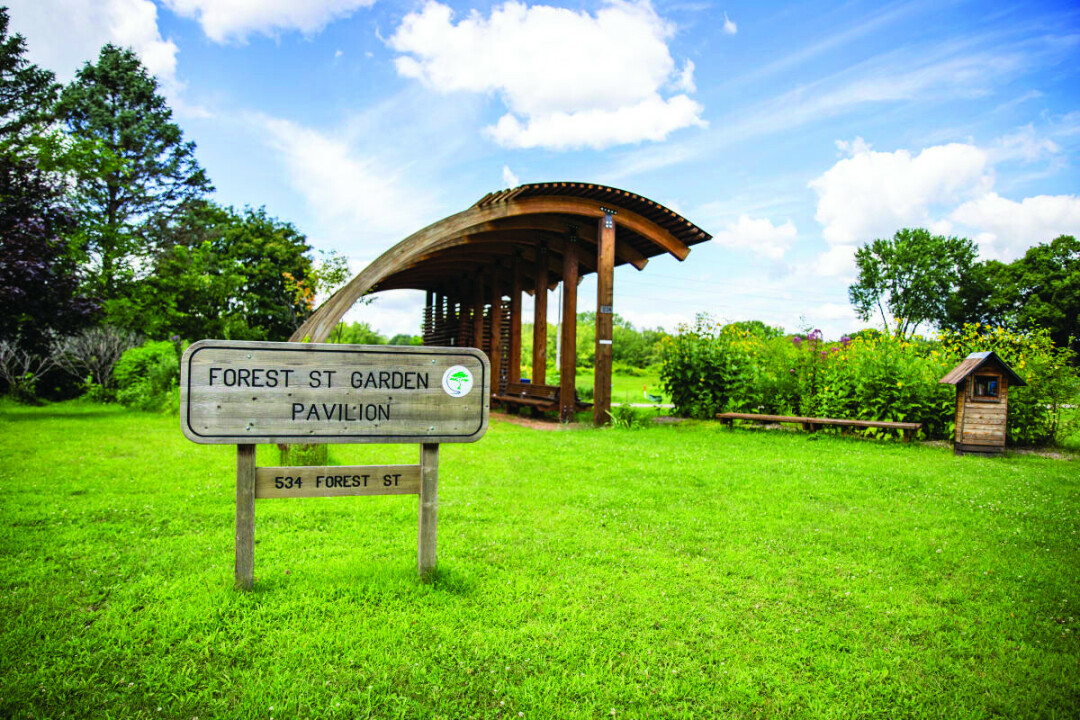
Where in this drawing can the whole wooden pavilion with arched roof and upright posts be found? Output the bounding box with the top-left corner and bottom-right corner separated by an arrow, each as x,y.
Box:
292,182 -> 711,424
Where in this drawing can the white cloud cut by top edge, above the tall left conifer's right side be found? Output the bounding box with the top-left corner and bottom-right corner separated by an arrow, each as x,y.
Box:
157,0 -> 375,43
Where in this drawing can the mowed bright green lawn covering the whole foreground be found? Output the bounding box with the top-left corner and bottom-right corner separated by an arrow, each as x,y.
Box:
0,404 -> 1080,720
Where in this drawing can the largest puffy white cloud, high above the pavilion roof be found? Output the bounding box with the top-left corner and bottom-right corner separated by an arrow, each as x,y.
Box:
389,0 -> 704,149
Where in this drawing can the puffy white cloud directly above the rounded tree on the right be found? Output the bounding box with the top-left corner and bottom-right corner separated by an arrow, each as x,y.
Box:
810,138 -> 994,246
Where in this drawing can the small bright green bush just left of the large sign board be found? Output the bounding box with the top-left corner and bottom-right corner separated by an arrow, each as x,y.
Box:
113,340 -> 180,410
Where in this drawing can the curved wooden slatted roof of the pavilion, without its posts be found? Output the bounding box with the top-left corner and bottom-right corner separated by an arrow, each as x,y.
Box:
292,182 -> 711,342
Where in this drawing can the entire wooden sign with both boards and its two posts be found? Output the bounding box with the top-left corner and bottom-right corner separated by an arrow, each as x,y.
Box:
180,340 -> 491,589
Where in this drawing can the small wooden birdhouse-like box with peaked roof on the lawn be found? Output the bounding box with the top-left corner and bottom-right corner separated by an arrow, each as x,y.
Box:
940,352 -> 1027,456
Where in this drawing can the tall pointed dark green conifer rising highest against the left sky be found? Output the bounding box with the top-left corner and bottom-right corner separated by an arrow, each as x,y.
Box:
58,44 -> 213,299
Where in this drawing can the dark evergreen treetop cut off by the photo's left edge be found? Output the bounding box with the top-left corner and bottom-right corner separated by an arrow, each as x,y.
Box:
0,6 -> 59,149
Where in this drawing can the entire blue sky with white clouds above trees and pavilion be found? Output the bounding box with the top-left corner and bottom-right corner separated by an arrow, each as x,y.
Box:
10,0 -> 1080,337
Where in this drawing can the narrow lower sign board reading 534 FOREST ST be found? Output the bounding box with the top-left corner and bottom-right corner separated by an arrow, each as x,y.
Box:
255,465 -> 420,500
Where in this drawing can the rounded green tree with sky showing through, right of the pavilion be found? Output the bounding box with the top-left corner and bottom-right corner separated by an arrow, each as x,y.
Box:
848,228 -> 975,336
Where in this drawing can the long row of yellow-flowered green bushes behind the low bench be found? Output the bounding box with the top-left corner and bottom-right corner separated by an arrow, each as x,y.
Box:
660,315 -> 1080,445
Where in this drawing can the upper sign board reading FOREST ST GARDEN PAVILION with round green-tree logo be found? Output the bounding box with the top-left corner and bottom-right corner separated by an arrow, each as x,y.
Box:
180,340 -> 491,445
